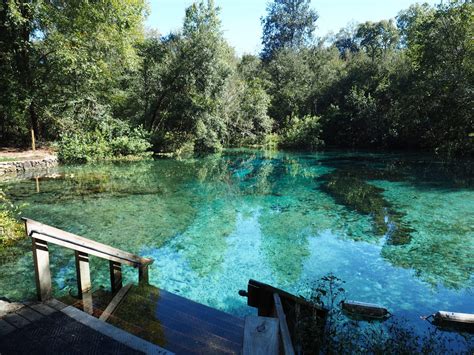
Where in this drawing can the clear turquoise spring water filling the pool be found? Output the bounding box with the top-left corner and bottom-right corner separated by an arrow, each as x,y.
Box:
0,150 -> 474,340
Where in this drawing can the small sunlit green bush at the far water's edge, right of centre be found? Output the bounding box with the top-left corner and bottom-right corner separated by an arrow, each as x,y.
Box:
279,115 -> 324,150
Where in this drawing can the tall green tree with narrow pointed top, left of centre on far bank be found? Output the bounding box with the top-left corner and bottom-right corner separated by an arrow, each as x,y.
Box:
135,1 -> 233,150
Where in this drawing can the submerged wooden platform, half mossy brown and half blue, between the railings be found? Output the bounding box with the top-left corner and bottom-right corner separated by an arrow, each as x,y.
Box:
107,285 -> 244,354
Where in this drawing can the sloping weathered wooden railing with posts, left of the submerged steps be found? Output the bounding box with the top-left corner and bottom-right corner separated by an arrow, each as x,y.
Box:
23,218 -> 153,311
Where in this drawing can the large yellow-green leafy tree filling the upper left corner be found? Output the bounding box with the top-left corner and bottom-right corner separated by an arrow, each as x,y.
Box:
0,0 -> 146,148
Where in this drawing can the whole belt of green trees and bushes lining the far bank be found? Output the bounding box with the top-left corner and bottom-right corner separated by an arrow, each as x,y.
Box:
0,0 -> 474,161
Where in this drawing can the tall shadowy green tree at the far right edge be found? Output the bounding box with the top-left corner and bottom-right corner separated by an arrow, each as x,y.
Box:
399,1 -> 474,155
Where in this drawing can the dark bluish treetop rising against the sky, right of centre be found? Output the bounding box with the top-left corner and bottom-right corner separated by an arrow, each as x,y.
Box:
261,0 -> 318,60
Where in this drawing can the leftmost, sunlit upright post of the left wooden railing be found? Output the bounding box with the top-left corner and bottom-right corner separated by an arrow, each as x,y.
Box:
31,238 -> 52,302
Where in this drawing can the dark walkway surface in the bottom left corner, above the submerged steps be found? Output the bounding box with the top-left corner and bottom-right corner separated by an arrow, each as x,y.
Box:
0,300 -> 170,355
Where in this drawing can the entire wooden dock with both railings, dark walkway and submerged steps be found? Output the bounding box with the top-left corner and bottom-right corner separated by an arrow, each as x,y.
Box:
0,219 -> 325,355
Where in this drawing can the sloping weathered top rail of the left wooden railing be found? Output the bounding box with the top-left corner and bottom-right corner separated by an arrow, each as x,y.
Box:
23,218 -> 153,267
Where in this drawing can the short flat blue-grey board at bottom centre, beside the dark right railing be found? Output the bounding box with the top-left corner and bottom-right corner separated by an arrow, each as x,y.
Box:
242,316 -> 279,355
